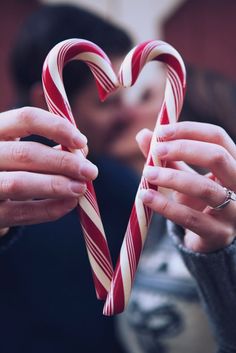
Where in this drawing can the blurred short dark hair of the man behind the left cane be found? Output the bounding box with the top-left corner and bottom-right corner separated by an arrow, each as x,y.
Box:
10,5 -> 132,105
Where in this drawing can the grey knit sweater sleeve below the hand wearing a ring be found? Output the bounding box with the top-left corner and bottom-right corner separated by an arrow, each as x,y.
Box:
168,222 -> 236,353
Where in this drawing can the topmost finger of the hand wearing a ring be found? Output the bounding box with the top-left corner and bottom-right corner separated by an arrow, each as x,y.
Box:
158,121 -> 236,158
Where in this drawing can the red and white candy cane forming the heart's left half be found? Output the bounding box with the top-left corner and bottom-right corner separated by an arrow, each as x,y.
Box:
42,39 -> 119,299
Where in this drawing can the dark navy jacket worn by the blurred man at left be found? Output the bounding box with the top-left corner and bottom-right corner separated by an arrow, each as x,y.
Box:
0,158 -> 138,353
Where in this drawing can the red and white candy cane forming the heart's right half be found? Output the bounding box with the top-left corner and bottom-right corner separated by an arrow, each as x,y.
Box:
103,41 -> 186,315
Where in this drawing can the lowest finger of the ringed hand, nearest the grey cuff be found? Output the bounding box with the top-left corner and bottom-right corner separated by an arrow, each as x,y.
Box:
139,189 -> 235,247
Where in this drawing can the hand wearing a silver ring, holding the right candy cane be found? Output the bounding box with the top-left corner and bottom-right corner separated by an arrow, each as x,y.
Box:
137,122 -> 236,252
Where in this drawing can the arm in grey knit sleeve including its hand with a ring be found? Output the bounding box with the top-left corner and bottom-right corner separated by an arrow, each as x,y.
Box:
138,122 -> 236,353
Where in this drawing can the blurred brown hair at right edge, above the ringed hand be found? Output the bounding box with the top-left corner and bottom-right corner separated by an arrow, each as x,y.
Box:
180,65 -> 236,141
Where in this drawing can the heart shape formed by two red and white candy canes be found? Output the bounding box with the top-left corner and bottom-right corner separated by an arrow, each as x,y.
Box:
42,39 -> 186,315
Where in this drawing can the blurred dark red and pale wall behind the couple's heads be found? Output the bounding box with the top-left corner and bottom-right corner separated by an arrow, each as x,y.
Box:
0,0 -> 236,111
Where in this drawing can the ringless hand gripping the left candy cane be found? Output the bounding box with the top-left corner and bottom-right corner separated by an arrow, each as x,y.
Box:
0,107 -> 97,228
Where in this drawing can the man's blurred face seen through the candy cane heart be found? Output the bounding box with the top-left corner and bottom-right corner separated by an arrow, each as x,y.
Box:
72,58 -> 133,155
